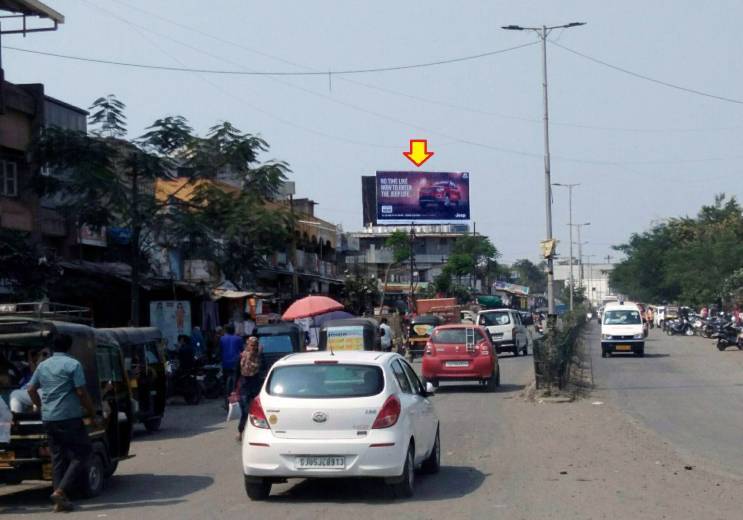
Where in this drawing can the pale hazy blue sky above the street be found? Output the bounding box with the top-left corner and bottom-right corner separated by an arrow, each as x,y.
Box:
2,0 -> 743,262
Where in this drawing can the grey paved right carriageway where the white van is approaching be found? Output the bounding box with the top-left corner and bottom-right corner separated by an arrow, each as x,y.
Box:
591,322 -> 743,476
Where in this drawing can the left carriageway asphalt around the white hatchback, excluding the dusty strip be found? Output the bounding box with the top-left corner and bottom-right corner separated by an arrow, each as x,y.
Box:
0,355 -> 533,520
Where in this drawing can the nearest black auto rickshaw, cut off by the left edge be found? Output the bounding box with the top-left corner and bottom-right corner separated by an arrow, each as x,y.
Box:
0,305 -> 132,497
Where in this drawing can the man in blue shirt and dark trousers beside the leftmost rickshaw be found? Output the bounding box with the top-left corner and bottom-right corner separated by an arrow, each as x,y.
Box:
28,334 -> 95,511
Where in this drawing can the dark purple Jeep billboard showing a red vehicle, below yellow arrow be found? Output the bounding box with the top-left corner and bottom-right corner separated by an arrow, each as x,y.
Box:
377,172 -> 470,220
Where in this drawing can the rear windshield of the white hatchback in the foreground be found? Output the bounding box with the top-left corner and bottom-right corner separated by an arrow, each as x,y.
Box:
266,364 -> 384,399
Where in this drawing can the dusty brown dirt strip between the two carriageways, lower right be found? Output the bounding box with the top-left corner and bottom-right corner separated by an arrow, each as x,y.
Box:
496,399 -> 743,520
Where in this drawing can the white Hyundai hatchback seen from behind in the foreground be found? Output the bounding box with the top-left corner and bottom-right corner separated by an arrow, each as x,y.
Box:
242,351 -> 441,500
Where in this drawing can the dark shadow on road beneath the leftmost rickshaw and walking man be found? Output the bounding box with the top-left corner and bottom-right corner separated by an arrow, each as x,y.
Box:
0,474 -> 214,515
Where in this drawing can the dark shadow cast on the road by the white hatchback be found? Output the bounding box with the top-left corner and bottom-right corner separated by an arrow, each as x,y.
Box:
269,466 -> 489,503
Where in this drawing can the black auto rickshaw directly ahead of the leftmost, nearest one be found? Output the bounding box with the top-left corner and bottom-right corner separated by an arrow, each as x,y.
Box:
96,327 -> 166,432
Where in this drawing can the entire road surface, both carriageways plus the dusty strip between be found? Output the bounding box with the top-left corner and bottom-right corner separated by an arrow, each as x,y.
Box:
0,325 -> 743,520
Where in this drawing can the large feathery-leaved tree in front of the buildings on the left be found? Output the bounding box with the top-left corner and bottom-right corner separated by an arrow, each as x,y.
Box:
32,96 -> 288,325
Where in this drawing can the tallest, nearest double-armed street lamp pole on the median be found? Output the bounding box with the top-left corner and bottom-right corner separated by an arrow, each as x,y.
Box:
502,22 -> 585,328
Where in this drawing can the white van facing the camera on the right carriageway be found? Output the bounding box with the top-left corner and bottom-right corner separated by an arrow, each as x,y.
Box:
601,302 -> 645,357
